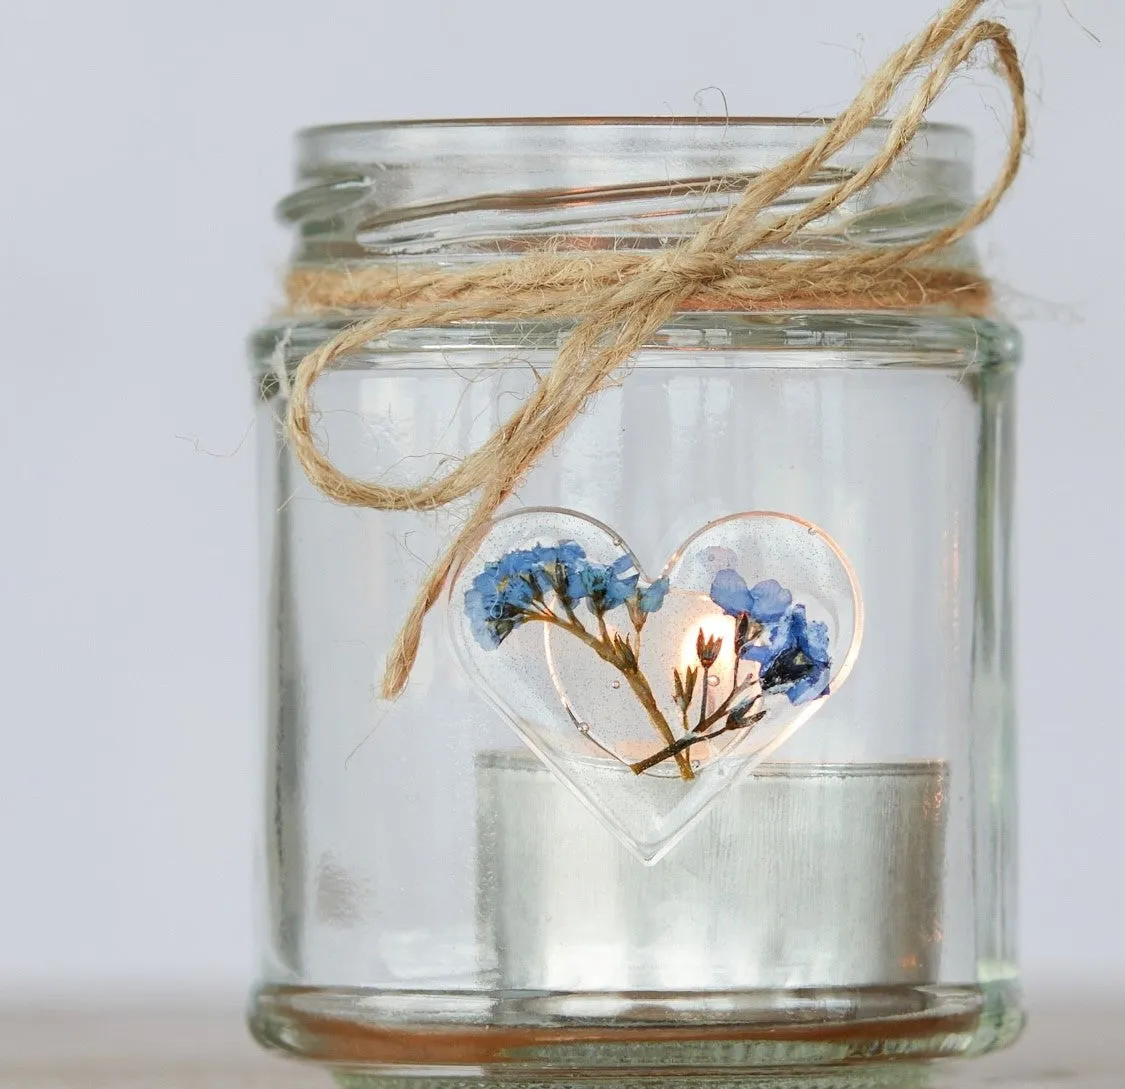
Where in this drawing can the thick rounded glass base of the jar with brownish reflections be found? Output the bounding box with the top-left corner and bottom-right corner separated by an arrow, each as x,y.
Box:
250,981 -> 1023,1089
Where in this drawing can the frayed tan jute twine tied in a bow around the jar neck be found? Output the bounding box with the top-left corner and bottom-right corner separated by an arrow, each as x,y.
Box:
288,0 -> 1027,699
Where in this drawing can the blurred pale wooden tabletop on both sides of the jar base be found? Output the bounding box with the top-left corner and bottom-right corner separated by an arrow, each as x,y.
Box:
0,1001 -> 1125,1089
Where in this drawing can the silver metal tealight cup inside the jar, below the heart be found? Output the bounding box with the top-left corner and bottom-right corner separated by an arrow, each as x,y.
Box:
477,752 -> 948,992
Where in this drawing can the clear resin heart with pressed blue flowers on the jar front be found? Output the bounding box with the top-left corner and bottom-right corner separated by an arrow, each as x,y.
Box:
449,509 -> 863,863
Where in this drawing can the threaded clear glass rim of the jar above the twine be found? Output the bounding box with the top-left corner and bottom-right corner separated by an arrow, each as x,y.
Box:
288,117 -> 972,264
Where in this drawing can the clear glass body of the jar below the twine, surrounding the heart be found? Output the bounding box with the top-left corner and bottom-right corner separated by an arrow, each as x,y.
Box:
251,315 -> 1019,1085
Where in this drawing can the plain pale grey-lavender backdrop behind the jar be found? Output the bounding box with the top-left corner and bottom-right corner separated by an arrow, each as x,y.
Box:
0,0 -> 1125,997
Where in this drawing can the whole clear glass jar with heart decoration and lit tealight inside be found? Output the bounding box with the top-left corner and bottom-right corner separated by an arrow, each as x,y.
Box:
251,119 -> 1022,1087
